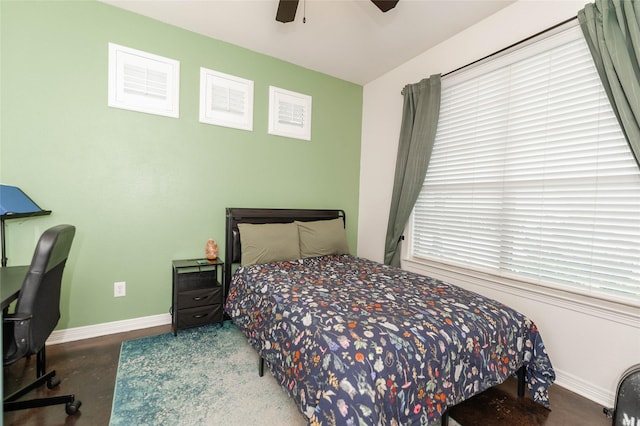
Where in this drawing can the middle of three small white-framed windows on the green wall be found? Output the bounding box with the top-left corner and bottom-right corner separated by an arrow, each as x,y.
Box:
200,68 -> 253,130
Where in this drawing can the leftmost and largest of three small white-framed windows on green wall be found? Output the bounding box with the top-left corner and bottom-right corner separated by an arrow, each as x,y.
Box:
108,43 -> 180,118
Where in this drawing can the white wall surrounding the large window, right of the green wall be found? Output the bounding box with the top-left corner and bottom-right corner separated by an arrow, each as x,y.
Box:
358,0 -> 640,405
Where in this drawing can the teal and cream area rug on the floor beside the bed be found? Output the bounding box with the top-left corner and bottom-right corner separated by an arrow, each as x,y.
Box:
110,321 -> 459,426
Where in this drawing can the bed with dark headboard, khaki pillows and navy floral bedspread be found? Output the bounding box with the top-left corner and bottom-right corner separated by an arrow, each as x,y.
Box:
225,209 -> 555,425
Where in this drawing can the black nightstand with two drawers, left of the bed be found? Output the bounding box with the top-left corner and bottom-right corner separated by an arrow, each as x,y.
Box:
171,259 -> 224,336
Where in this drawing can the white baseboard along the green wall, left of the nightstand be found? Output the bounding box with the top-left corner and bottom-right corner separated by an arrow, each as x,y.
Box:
47,314 -> 171,345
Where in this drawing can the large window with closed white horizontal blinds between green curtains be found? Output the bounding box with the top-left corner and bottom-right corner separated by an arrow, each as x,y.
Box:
409,26 -> 640,305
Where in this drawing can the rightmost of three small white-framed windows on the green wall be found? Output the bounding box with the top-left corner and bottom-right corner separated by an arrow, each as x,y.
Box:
269,86 -> 311,141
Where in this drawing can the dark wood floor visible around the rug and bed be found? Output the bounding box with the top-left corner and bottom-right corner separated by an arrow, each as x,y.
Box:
3,326 -> 611,426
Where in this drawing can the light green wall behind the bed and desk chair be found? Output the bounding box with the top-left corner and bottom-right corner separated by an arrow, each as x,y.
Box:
0,0 -> 362,329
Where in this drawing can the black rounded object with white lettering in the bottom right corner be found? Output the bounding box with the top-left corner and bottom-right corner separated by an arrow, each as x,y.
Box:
603,364 -> 640,426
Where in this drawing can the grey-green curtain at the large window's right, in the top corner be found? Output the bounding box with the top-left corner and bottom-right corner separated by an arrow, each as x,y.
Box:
578,0 -> 640,166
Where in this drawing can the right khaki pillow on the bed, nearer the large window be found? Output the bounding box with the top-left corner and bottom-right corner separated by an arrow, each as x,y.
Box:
296,218 -> 349,257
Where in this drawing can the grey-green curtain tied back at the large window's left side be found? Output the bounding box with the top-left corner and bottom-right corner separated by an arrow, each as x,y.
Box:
384,74 -> 441,266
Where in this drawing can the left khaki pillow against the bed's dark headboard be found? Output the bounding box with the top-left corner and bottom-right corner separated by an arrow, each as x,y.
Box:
238,223 -> 300,266
